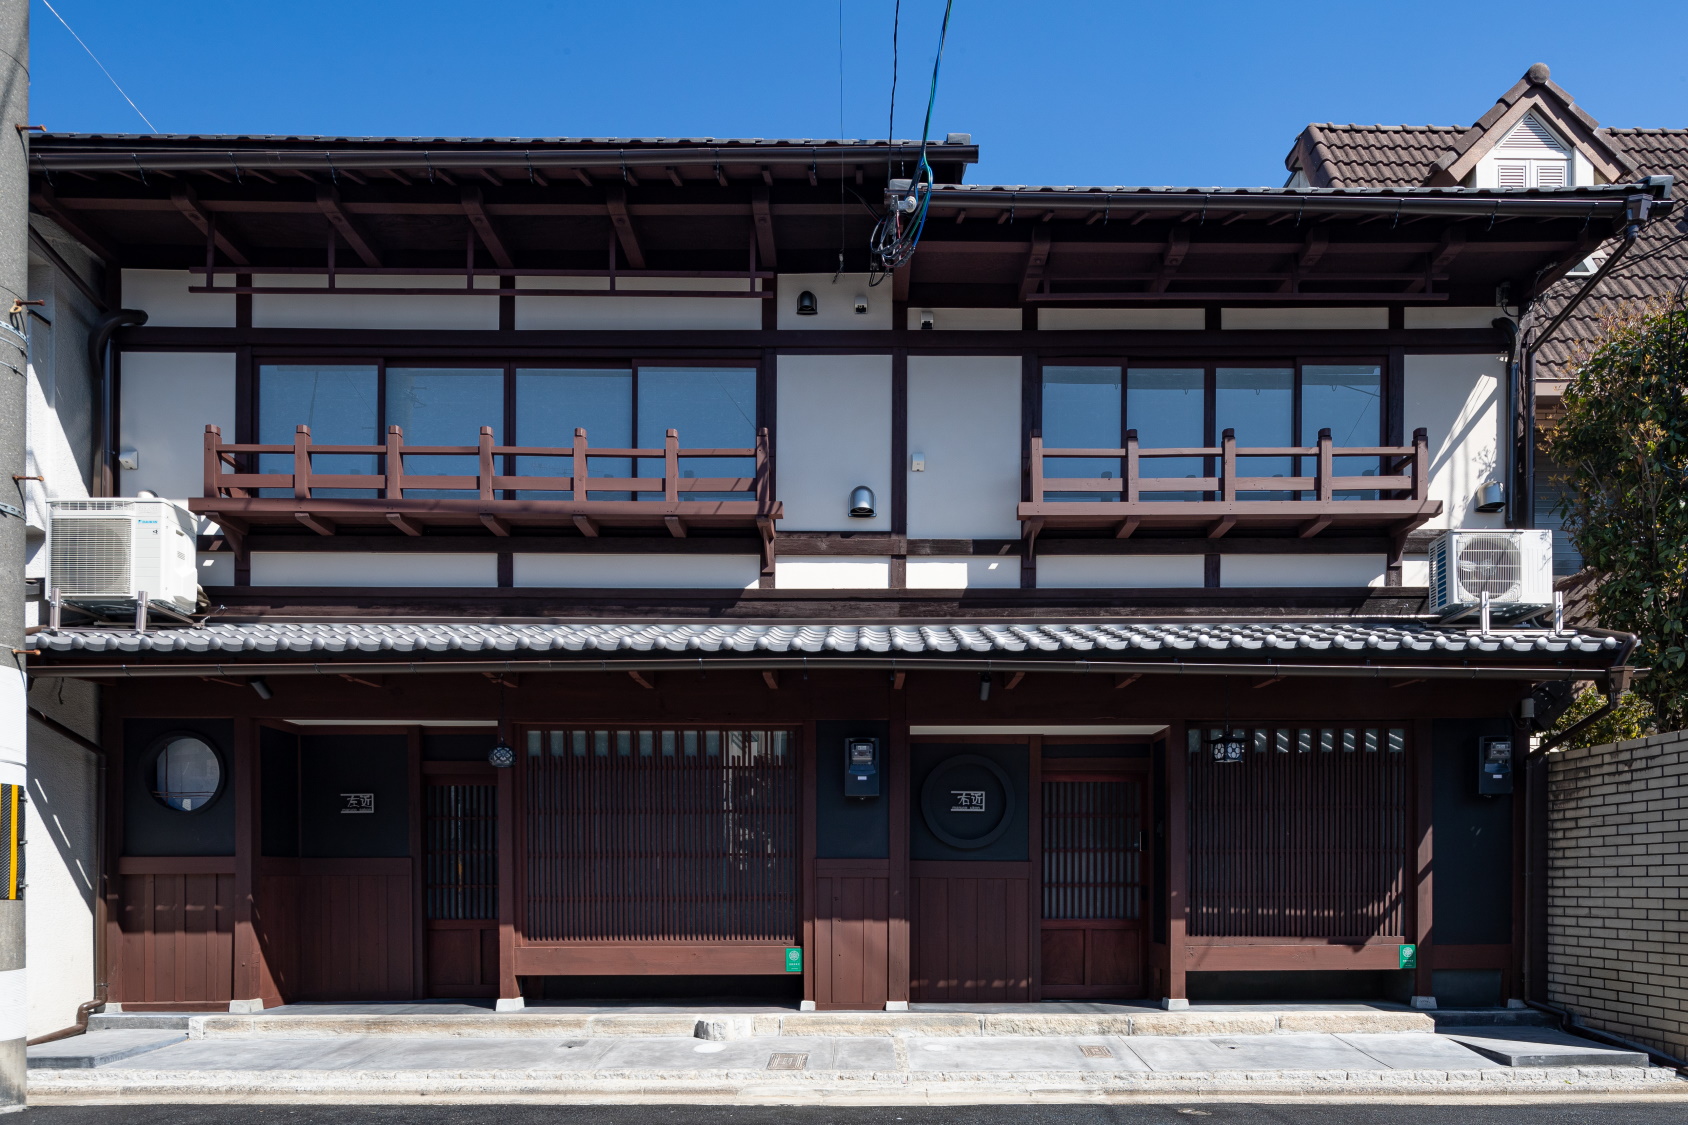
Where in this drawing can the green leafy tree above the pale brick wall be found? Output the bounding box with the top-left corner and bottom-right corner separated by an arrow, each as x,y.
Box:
1545,294 -> 1688,730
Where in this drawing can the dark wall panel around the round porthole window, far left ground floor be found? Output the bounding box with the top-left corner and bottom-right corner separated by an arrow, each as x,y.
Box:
123,720 -> 235,855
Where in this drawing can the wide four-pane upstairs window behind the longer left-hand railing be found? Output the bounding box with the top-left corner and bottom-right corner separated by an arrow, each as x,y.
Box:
257,363 -> 756,500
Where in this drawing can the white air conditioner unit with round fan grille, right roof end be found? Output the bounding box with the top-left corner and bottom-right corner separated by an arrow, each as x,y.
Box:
1430,530 -> 1553,622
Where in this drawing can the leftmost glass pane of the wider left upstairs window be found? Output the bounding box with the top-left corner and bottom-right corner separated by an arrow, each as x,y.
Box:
256,363 -> 381,497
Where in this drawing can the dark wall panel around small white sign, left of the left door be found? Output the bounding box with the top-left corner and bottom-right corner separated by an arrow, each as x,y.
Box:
299,735 -> 410,860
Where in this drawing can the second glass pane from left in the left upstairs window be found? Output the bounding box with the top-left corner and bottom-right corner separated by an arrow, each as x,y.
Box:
387,367 -> 505,498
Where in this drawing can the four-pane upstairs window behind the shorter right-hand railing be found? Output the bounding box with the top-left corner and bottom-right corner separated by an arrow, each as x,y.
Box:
1041,363 -> 1384,500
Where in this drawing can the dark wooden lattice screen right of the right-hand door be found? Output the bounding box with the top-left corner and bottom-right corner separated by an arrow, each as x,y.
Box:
1188,725 -> 1408,938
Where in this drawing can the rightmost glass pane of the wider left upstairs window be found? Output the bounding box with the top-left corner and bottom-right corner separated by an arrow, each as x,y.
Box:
638,367 -> 756,500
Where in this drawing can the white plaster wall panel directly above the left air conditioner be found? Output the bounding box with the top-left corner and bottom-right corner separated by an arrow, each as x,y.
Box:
116,351 -> 235,500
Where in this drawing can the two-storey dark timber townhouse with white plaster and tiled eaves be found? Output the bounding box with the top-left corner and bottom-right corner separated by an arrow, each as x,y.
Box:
16,131 -> 1673,1019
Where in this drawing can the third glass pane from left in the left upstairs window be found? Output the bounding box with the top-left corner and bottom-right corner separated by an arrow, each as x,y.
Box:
511,368 -> 633,500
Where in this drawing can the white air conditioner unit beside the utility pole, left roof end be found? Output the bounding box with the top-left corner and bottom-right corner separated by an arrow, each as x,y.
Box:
47,498 -> 199,615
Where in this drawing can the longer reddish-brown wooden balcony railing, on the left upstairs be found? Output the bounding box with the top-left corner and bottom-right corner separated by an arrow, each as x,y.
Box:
189,426 -> 782,556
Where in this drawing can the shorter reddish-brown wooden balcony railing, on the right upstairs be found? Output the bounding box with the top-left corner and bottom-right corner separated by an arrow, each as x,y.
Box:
1020,429 -> 1442,541
